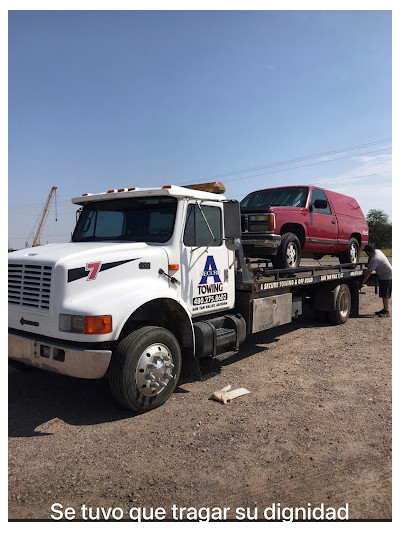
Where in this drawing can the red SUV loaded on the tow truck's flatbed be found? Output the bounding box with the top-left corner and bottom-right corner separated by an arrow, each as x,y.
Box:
240,186 -> 368,268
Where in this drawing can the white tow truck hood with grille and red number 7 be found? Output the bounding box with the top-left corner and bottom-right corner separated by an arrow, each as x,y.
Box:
8,242 -> 170,342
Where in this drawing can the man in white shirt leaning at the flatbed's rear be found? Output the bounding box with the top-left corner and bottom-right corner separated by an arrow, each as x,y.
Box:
360,244 -> 392,316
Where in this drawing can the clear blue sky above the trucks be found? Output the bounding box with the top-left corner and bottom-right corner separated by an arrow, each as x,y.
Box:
9,11 -> 392,248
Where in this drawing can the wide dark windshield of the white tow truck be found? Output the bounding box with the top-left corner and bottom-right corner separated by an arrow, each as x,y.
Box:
72,196 -> 177,243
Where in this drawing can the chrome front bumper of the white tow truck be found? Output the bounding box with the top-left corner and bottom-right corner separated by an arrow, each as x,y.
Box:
8,333 -> 111,379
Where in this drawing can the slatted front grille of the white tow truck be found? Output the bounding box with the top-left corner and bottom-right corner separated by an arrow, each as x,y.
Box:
8,263 -> 52,309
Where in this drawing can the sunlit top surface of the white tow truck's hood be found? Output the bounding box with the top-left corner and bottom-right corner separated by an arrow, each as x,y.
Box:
8,242 -> 160,264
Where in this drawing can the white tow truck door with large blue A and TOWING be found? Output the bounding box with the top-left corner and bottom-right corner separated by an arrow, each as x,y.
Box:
181,201 -> 235,316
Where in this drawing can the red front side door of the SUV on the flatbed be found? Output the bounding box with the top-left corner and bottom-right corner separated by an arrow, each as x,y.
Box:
308,189 -> 338,252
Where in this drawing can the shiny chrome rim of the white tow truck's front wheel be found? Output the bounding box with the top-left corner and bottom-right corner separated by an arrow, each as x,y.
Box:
136,343 -> 174,396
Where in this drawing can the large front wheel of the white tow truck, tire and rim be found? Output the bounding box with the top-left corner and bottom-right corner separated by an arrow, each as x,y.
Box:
108,326 -> 182,413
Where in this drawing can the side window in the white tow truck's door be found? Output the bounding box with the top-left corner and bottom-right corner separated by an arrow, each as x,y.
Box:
183,204 -> 222,246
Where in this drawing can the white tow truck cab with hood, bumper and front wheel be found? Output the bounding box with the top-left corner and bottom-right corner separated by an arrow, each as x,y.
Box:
8,185 -> 243,408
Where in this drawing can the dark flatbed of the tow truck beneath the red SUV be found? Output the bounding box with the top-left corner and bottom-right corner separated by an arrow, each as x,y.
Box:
231,251 -> 364,334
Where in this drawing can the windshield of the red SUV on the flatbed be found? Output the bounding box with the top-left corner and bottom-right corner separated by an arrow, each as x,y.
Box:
240,187 -> 308,207
